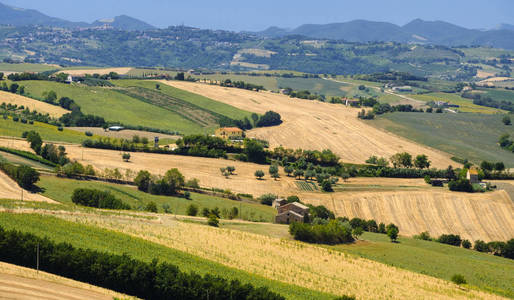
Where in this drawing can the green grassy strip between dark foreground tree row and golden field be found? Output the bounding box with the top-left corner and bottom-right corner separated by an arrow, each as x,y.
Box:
0,213 -> 332,299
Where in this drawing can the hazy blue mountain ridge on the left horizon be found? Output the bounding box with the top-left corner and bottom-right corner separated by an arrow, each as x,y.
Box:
0,3 -> 156,31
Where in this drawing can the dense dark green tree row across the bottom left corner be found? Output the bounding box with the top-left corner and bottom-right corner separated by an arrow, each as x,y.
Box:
0,227 -> 284,300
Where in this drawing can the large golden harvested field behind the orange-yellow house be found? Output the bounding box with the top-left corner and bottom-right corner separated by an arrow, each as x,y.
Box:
161,81 -> 457,168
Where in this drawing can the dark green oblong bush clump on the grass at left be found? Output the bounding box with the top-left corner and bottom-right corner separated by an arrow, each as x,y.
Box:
71,188 -> 130,209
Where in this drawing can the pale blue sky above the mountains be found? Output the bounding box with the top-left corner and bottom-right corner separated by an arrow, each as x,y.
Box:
0,0 -> 514,31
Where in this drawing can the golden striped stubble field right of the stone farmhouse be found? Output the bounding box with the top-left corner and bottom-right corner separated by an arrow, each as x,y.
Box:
300,189 -> 514,241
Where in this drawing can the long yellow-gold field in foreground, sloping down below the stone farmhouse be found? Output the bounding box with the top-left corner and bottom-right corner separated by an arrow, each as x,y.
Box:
57,214 -> 499,299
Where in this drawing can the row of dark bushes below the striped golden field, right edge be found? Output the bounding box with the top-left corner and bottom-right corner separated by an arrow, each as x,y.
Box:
414,231 -> 514,259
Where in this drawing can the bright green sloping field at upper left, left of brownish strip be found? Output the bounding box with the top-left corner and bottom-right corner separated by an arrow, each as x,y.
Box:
19,81 -> 203,134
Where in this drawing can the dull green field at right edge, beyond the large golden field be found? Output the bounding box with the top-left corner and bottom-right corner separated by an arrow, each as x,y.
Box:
370,113 -> 514,167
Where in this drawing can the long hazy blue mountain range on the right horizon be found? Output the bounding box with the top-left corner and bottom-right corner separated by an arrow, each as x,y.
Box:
255,19 -> 514,49
